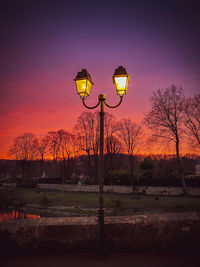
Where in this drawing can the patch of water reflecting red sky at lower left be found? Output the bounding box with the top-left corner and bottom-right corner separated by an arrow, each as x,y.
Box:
0,210 -> 40,222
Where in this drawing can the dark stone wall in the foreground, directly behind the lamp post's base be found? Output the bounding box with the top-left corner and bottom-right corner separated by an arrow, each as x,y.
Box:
0,213 -> 200,253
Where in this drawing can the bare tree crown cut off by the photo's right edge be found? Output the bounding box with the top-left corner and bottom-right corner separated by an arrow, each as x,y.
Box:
184,95 -> 200,151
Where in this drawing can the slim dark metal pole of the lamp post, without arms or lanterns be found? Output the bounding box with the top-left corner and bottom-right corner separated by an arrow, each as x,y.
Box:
97,95 -> 106,257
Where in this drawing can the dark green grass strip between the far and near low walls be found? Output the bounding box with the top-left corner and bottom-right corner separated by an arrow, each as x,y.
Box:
1,189 -> 200,216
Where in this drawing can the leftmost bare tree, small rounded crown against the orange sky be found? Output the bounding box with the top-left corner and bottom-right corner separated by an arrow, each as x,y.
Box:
8,133 -> 38,179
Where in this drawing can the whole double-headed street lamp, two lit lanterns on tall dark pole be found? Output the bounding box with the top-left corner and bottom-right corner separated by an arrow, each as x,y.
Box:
74,66 -> 129,257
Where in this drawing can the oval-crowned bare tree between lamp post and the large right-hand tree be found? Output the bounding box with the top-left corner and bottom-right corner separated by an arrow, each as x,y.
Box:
118,119 -> 144,193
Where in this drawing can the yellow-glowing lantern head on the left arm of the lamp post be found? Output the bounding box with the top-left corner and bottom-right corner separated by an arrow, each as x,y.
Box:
74,69 -> 94,98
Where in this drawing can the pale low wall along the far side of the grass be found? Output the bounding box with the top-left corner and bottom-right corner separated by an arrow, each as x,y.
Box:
37,184 -> 200,196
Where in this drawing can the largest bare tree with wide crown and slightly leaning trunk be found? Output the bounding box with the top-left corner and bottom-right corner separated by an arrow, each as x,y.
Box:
144,85 -> 186,194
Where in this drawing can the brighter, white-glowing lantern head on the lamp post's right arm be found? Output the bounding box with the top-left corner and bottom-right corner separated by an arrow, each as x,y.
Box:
113,66 -> 129,96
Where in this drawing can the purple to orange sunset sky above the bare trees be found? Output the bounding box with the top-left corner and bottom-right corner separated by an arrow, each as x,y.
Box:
0,0 -> 200,158
